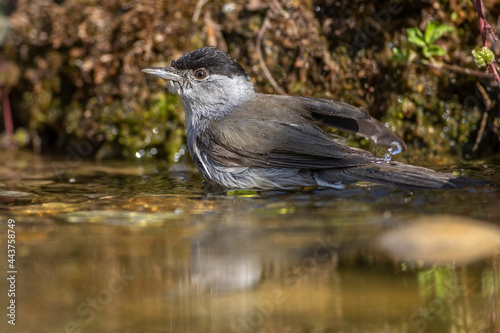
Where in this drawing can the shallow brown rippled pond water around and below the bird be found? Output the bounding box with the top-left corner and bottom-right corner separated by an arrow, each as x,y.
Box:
0,152 -> 500,332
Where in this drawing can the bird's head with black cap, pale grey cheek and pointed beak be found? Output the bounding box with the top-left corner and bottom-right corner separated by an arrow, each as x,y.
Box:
142,47 -> 255,119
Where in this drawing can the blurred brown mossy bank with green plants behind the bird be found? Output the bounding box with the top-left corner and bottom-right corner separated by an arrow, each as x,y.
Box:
0,0 -> 500,160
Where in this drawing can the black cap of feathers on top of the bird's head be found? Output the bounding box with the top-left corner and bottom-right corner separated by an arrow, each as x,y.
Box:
171,46 -> 248,77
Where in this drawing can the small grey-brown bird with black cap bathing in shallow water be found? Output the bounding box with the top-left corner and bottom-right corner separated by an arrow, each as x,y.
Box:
142,47 -> 480,189
